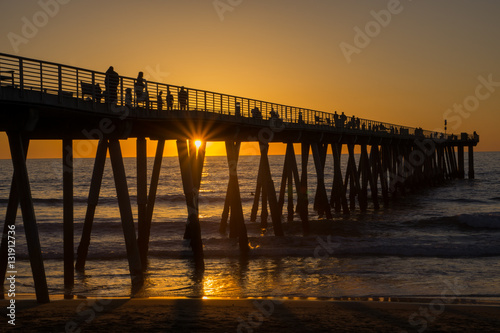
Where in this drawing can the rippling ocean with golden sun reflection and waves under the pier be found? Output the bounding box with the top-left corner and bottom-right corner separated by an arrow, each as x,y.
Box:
0,152 -> 500,300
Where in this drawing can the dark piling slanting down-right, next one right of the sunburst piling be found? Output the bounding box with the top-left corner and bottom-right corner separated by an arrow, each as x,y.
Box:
226,141 -> 249,254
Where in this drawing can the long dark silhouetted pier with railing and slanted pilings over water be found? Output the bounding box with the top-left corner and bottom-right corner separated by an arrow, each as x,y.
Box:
0,54 -> 479,302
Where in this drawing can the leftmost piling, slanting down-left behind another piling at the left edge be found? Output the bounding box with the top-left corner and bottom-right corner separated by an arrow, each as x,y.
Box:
0,140 -> 29,299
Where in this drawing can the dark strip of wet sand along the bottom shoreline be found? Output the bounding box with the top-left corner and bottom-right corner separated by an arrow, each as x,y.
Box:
0,298 -> 500,332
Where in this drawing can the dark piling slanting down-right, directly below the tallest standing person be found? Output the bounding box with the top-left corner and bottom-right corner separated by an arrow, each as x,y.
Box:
109,139 -> 144,287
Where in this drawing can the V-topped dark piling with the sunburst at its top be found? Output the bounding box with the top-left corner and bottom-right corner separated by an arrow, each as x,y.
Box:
177,140 -> 206,269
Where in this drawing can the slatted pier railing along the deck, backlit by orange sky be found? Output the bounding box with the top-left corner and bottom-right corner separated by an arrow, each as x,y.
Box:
0,53 -> 477,140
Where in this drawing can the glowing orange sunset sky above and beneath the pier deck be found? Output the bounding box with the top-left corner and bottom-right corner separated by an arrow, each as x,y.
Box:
0,0 -> 500,158
